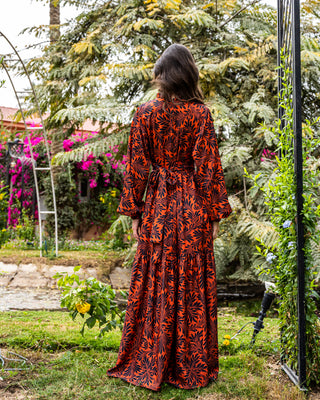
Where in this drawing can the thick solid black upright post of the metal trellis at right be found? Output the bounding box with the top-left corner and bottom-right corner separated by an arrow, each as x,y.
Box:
292,0 -> 306,386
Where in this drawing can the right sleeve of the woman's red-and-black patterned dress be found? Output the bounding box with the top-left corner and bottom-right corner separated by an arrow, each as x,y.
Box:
193,109 -> 232,221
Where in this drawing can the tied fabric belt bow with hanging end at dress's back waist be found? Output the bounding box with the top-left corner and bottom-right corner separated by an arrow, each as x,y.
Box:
149,166 -> 193,243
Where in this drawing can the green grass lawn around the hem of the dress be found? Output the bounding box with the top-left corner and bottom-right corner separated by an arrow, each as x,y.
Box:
0,307 -> 305,400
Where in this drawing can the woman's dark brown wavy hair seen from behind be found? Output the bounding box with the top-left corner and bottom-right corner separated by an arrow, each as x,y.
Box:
153,44 -> 203,103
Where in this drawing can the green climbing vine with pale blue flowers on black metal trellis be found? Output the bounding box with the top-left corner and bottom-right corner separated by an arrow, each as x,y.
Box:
250,56 -> 320,385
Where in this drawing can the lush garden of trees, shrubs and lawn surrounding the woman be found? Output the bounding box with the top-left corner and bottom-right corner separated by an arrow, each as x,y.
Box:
0,0 -> 320,400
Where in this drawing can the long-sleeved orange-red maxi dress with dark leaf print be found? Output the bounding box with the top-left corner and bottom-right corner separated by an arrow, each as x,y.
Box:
107,94 -> 231,390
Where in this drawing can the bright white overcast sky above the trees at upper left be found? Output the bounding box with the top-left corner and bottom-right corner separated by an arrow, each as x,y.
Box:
0,0 -> 277,107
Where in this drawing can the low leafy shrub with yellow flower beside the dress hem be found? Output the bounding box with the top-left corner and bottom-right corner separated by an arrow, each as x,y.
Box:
54,266 -> 126,336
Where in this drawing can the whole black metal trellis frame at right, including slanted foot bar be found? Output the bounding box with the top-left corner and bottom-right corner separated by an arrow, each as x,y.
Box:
278,0 -> 306,388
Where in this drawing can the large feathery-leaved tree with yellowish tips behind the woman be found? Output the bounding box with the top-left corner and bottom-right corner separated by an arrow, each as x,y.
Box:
22,0 -> 320,278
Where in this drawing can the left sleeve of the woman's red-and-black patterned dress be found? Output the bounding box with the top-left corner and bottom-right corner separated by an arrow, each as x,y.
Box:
117,109 -> 150,218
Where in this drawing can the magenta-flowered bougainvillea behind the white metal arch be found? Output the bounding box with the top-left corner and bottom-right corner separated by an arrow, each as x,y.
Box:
0,123 -> 126,236
